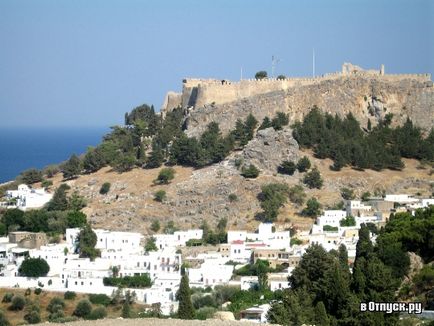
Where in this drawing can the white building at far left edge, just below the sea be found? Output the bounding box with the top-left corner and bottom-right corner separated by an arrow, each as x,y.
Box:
6,184 -> 53,211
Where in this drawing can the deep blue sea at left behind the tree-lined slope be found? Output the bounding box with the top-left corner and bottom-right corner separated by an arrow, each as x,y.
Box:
0,127 -> 109,183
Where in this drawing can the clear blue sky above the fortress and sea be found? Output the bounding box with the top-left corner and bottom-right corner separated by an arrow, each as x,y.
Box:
0,0 -> 434,127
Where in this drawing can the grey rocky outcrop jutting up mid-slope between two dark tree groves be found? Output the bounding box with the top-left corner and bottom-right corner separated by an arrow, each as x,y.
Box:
239,128 -> 299,174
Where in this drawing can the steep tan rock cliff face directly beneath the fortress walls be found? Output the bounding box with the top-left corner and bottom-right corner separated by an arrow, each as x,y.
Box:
186,75 -> 434,136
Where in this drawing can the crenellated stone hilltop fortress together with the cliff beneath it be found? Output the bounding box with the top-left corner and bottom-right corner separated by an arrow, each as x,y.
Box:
161,63 -> 434,136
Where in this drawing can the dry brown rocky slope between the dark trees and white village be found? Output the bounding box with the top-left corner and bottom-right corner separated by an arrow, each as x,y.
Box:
47,128 -> 434,234
